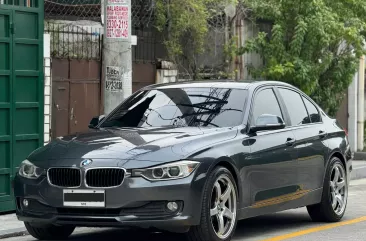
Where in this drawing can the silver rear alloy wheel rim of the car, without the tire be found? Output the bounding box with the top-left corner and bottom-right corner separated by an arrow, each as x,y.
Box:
330,163 -> 348,215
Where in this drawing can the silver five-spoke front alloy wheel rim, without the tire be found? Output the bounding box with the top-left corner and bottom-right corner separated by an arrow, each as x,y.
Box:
210,174 -> 237,239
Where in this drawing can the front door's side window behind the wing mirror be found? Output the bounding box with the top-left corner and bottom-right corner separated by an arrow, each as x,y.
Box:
252,89 -> 283,124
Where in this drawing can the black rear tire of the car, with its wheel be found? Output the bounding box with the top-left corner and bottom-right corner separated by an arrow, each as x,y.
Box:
307,157 -> 348,222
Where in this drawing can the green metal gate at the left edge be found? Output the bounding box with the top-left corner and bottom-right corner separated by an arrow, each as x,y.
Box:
0,0 -> 44,212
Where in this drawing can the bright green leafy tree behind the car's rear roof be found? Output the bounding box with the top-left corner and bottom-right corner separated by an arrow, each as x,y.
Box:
237,0 -> 366,115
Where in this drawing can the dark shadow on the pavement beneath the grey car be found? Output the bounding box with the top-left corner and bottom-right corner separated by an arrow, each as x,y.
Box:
42,209 -> 316,241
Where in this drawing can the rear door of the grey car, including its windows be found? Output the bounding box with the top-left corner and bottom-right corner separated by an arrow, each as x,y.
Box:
278,87 -> 327,191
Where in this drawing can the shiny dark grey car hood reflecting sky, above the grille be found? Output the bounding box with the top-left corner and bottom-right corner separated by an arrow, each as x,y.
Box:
28,127 -> 237,168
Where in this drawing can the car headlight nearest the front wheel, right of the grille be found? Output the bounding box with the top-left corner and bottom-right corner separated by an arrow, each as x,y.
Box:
132,161 -> 199,181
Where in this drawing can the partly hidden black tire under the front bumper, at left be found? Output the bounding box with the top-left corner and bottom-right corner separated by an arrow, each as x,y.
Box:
24,222 -> 75,240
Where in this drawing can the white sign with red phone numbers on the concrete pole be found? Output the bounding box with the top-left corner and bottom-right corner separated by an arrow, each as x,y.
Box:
107,5 -> 129,39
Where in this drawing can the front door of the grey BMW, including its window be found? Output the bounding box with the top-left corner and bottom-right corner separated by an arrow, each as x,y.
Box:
244,88 -> 299,208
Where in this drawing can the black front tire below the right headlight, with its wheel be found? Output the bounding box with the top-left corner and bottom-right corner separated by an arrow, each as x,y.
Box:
187,166 -> 239,241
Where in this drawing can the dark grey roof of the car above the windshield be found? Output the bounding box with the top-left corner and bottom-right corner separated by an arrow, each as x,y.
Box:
144,80 -> 296,89
